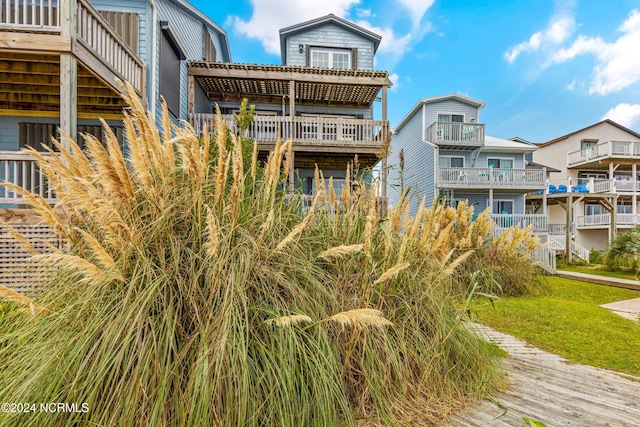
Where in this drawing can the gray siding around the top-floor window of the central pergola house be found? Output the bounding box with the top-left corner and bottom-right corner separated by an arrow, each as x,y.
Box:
283,23 -> 373,70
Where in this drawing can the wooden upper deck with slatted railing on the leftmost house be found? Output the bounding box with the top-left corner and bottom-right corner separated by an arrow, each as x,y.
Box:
0,0 -> 146,115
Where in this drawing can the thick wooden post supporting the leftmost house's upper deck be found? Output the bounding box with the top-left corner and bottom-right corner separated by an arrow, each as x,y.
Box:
60,0 -> 78,149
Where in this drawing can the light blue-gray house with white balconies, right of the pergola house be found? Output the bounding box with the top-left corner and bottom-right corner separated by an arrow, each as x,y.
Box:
388,94 -> 546,231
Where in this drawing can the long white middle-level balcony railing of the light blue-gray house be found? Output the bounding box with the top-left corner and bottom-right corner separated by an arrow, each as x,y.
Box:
437,168 -> 546,191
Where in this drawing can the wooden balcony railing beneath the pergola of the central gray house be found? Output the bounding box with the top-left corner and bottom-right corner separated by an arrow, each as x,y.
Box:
189,113 -> 389,147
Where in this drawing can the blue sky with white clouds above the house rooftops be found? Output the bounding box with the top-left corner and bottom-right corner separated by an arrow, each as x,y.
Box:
192,0 -> 640,142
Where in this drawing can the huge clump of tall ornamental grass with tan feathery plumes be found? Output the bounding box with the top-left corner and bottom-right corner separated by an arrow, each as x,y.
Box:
0,84 -> 502,427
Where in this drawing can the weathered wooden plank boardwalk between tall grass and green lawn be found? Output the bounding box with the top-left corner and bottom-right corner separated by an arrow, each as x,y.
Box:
446,325 -> 640,427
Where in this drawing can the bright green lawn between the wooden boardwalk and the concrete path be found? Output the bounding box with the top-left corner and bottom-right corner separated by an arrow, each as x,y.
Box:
472,277 -> 640,375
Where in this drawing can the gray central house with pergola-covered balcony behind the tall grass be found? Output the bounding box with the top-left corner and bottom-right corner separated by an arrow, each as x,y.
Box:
188,14 -> 391,205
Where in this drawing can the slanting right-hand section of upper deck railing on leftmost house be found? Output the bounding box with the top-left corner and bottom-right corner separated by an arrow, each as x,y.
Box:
76,0 -> 145,91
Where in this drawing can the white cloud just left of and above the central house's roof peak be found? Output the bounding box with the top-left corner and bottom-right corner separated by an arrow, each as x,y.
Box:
231,0 -> 359,54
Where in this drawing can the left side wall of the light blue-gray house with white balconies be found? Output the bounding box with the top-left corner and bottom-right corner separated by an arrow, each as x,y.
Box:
387,105 -> 437,215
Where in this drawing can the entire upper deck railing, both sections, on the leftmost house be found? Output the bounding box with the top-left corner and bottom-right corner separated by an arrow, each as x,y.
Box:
0,0 -> 145,92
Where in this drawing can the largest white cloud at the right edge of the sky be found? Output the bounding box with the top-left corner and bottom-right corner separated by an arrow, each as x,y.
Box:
552,10 -> 640,95
